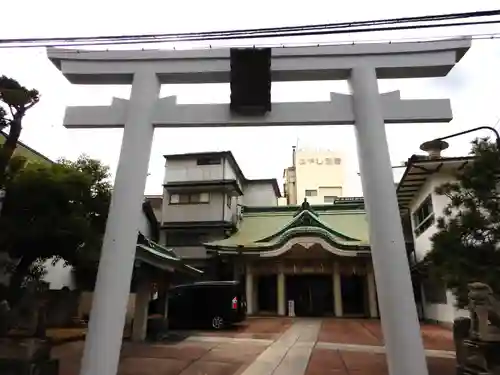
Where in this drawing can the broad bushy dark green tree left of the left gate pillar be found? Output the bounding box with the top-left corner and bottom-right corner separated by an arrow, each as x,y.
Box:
0,156 -> 111,303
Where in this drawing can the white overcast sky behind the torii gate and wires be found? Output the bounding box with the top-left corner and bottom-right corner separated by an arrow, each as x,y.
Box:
0,0 -> 500,196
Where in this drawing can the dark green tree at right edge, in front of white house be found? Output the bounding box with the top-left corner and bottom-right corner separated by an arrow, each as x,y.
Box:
424,138 -> 500,308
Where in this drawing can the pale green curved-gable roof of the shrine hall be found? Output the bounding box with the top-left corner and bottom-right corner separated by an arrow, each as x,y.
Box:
205,208 -> 369,250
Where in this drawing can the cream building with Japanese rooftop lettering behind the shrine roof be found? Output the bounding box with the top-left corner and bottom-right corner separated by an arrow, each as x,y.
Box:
295,149 -> 345,204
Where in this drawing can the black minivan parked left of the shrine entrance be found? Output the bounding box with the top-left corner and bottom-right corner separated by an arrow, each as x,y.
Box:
168,281 -> 246,329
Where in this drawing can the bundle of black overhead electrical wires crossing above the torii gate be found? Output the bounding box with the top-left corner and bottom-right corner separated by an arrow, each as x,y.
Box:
0,10 -> 500,48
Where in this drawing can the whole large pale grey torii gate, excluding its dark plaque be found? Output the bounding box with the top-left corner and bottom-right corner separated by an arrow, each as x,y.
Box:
48,39 -> 470,375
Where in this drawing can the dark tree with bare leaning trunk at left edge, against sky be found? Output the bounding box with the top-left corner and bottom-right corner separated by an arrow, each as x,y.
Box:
0,76 -> 40,188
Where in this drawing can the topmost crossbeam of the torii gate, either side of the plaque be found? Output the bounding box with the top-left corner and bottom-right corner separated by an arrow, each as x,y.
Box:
47,38 -> 471,85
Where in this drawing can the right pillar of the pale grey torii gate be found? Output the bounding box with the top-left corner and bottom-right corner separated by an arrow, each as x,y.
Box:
350,66 -> 428,375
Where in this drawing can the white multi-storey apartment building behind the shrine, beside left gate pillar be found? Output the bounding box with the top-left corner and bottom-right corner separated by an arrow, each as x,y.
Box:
160,151 -> 281,278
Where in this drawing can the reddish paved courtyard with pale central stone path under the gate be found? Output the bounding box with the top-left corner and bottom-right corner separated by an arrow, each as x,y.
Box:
54,318 -> 455,375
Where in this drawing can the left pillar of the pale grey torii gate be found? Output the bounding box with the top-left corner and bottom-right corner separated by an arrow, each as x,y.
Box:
80,70 -> 160,375
